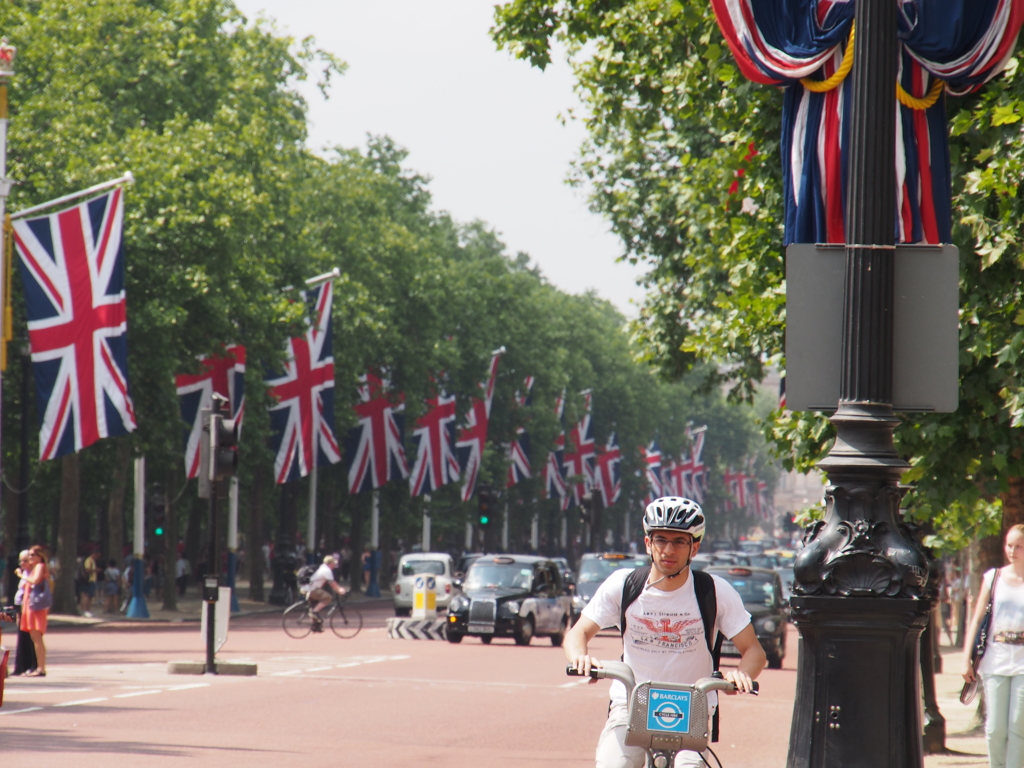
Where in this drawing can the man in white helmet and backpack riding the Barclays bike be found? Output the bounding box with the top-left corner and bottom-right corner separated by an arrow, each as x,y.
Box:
562,497 -> 766,768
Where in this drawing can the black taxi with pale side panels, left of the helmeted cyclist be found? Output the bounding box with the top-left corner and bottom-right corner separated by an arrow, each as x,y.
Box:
447,555 -> 572,646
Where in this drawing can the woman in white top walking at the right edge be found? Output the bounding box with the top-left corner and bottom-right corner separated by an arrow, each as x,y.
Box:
964,525 -> 1024,768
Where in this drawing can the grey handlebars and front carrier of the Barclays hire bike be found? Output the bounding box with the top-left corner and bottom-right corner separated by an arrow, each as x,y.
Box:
566,660 -> 758,768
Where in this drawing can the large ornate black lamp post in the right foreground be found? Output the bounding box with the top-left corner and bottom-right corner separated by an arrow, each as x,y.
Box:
787,0 -> 929,768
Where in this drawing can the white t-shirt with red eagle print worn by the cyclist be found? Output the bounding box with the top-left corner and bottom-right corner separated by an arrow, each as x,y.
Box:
583,568 -> 751,707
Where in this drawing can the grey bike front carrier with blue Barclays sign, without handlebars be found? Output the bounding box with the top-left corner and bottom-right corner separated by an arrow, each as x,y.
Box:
626,683 -> 708,753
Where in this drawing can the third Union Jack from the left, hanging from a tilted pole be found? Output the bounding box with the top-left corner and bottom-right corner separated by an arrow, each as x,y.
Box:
266,281 -> 341,483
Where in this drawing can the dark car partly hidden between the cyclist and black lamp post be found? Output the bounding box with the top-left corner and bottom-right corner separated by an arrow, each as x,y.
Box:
705,565 -> 788,670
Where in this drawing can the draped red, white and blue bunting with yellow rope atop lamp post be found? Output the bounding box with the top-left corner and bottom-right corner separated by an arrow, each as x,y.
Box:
712,0 -> 1024,245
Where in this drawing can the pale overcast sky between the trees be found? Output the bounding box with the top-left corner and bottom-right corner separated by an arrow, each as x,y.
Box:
236,0 -> 643,315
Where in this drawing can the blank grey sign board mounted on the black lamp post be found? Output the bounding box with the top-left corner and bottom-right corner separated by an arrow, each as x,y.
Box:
785,244 -> 959,413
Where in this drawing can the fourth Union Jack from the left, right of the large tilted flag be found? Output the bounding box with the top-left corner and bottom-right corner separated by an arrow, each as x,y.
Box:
345,374 -> 409,494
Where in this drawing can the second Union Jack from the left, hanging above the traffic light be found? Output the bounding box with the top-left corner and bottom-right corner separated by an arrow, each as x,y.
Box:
174,344 -> 246,479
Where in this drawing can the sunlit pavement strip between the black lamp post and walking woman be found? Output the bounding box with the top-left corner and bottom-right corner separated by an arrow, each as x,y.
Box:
925,645 -> 988,768
